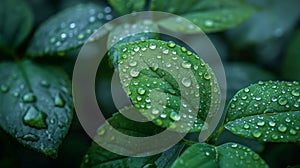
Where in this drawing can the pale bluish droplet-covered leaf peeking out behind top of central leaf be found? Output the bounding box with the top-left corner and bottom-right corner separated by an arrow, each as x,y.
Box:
107,20 -> 159,67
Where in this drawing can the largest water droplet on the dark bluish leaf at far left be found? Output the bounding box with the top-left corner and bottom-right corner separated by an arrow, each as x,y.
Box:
23,106 -> 47,129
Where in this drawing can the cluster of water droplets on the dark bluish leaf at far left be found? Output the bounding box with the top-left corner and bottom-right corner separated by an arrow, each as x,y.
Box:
0,68 -> 71,141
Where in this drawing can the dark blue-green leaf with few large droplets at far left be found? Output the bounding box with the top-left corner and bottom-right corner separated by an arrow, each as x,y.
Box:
0,61 -> 73,157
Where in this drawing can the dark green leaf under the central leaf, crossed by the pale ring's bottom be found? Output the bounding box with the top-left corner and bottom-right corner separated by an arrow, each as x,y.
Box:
81,113 -> 184,168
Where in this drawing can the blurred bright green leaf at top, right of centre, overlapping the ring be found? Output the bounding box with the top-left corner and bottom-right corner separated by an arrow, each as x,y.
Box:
158,1 -> 255,33
